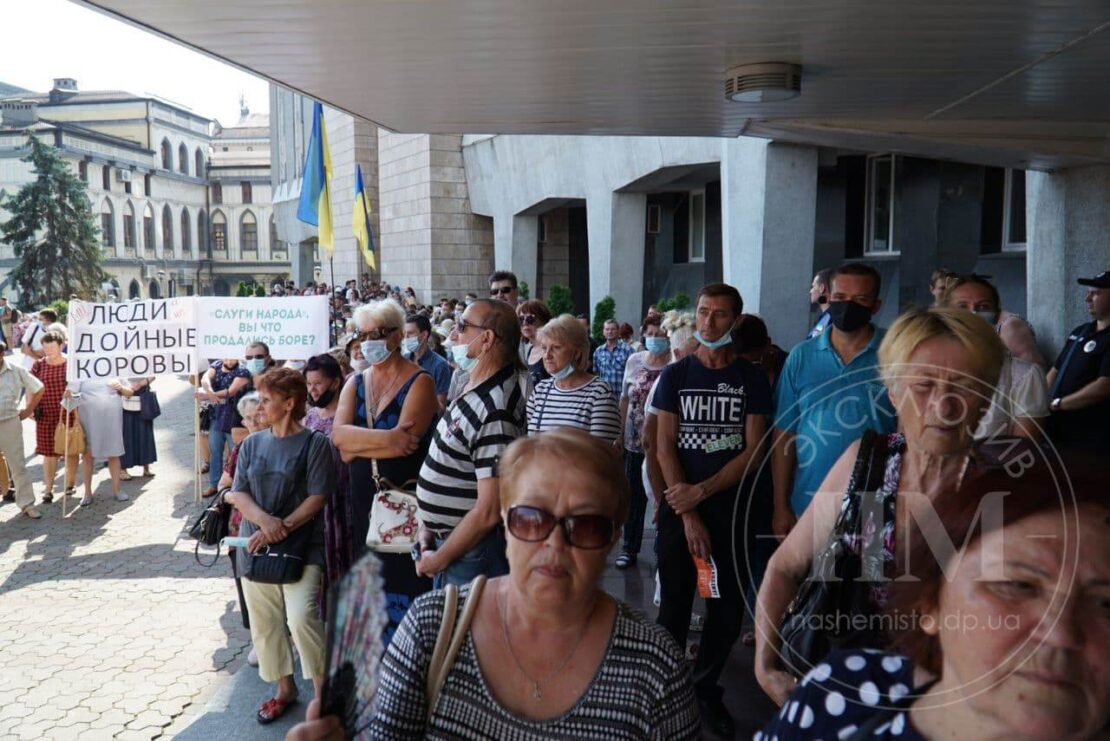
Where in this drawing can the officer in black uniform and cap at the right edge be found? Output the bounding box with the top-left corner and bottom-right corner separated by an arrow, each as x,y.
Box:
1048,271 -> 1110,453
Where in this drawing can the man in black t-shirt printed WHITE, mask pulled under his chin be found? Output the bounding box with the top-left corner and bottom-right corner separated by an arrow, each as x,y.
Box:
652,283 -> 771,738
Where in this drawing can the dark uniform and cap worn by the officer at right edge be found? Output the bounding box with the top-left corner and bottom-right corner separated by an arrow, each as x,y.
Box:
1049,273 -> 1110,453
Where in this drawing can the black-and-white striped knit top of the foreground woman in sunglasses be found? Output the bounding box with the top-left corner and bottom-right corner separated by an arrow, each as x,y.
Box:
372,586 -> 702,741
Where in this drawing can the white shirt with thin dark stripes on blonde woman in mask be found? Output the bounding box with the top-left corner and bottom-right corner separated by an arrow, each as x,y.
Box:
528,376 -> 620,443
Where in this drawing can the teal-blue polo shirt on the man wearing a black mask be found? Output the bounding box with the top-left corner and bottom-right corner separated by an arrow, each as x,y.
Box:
775,327 -> 897,516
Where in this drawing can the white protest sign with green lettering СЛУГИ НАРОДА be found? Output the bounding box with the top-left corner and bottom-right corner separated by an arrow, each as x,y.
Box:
195,296 -> 331,362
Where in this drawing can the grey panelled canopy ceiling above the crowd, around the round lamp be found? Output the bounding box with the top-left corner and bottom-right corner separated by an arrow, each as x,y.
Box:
77,0 -> 1110,168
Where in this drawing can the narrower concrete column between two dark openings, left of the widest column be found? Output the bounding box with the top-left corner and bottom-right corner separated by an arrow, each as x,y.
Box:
586,192 -> 647,326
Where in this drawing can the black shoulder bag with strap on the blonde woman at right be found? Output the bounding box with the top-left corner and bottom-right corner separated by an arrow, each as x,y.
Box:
778,430 -> 889,677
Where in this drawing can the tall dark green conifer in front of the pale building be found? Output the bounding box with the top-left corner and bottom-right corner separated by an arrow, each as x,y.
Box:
0,134 -> 108,306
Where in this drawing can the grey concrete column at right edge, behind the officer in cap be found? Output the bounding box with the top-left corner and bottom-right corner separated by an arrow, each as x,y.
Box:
1026,165 -> 1110,362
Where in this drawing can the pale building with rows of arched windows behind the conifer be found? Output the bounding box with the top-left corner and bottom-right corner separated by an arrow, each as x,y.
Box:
0,78 -> 279,301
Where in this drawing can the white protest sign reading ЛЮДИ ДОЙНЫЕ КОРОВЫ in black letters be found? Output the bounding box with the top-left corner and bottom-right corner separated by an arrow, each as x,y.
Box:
65,297 -> 196,382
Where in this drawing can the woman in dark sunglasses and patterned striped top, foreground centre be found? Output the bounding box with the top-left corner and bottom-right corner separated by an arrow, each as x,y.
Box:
289,429 -> 699,740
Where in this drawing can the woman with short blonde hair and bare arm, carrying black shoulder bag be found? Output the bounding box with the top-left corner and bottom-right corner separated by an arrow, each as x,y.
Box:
756,307 -> 1006,704
